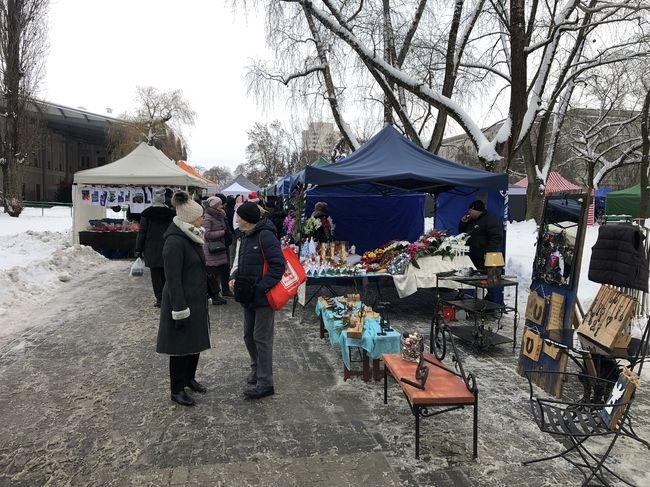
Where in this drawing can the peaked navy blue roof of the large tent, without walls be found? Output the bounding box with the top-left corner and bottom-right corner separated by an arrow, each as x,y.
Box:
305,125 -> 508,193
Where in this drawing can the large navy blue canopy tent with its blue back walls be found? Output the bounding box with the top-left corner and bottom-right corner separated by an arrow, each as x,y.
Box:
305,125 -> 508,250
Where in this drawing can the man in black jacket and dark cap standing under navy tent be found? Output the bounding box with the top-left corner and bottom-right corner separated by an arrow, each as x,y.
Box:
458,200 -> 503,301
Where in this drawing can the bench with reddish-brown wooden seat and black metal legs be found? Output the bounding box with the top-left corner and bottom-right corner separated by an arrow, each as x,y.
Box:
382,331 -> 478,459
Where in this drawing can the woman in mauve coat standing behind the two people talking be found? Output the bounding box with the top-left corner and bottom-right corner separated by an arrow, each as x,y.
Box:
203,196 -> 228,305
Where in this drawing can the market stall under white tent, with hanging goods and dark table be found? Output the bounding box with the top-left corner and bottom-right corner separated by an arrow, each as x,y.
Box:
72,143 -> 207,254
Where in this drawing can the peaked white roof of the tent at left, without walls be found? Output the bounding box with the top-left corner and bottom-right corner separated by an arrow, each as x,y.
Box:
74,142 -> 207,188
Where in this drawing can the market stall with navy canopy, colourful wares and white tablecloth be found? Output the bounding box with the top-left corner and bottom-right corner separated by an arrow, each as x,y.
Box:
305,125 -> 508,295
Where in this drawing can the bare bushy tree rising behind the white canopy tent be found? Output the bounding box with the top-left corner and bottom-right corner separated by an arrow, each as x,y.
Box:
108,86 -> 196,160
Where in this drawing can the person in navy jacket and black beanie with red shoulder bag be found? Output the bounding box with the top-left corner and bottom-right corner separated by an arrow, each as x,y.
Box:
230,202 -> 285,399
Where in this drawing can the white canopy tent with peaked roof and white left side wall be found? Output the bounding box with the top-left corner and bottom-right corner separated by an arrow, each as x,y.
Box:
72,142 -> 207,243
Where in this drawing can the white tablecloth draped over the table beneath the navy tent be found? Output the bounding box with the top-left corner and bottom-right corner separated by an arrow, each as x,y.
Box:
393,255 -> 475,298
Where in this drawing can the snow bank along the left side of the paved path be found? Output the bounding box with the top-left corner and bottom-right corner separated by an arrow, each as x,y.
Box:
0,208 -> 108,339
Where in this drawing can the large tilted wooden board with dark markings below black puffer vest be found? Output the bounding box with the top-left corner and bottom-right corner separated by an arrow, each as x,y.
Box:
578,286 -> 636,353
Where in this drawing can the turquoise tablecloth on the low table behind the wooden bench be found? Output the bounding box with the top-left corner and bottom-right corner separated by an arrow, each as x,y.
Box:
316,301 -> 401,369
